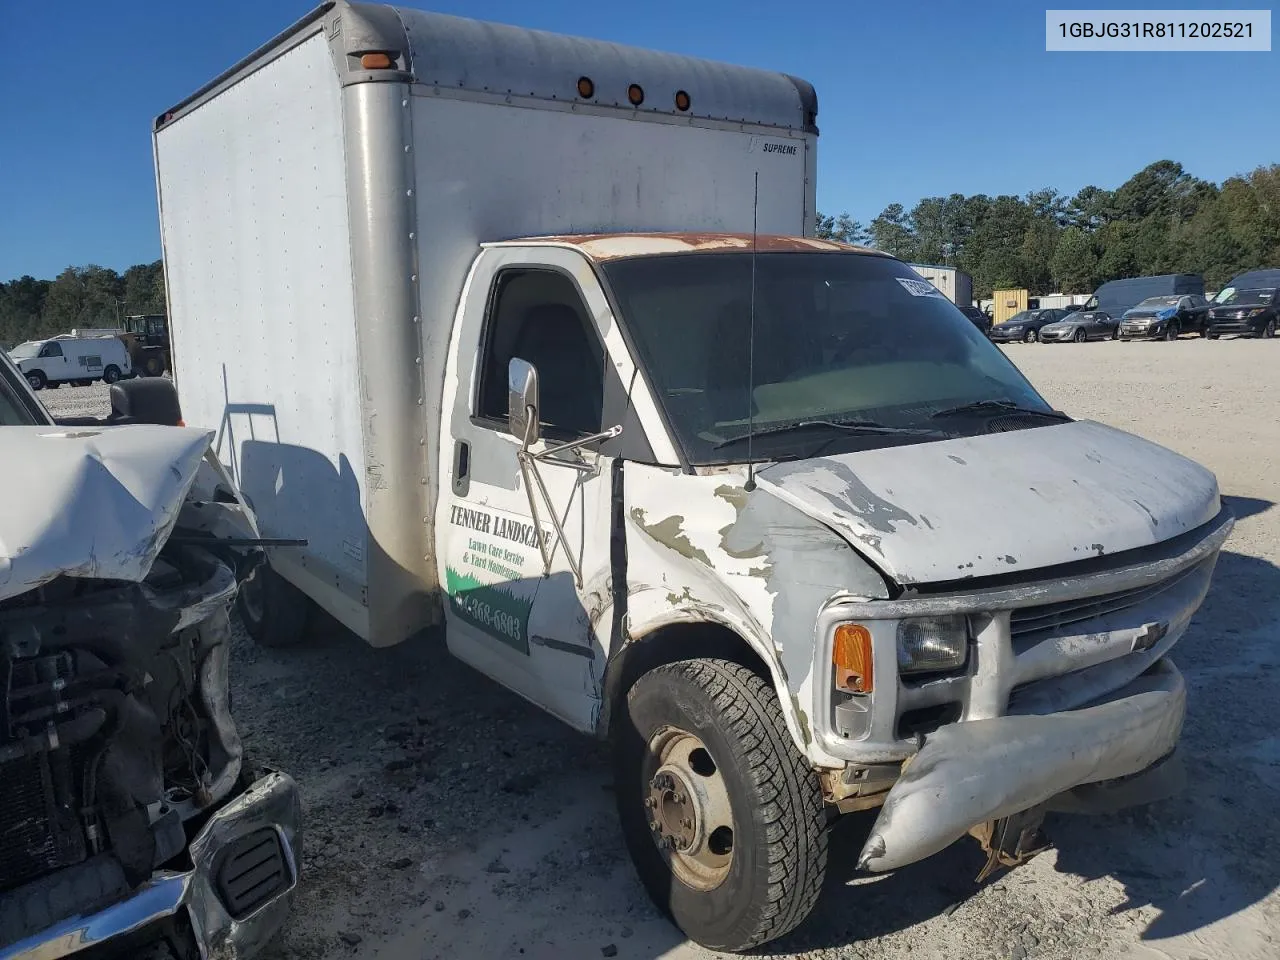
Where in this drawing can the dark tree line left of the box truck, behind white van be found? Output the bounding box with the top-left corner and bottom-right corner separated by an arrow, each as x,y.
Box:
0,260 -> 165,347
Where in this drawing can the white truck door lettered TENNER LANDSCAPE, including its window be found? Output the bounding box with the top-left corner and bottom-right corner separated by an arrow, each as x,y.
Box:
435,247 -> 652,730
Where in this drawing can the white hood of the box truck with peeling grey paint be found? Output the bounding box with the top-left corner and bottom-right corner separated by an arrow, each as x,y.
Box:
756,421 -> 1221,586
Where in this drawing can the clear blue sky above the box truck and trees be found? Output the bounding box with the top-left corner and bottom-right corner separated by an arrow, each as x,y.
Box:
0,0 -> 1280,279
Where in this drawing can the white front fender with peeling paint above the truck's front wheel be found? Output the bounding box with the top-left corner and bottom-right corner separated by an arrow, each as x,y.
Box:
623,463 -> 888,765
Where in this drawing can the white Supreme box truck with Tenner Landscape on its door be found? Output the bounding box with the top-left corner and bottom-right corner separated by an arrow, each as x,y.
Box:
154,3 -> 1231,950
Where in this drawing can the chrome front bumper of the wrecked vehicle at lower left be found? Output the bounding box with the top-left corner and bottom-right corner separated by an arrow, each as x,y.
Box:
0,773 -> 302,960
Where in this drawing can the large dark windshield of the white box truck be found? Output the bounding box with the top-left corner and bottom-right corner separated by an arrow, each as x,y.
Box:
602,252 -> 1051,465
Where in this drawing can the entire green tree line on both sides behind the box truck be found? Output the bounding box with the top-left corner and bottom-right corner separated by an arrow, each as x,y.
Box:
0,160 -> 1280,347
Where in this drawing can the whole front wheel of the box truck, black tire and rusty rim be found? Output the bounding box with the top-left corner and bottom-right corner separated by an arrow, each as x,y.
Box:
613,659 -> 827,952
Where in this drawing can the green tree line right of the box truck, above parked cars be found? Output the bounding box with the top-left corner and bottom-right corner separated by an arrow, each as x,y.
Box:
818,160 -> 1280,297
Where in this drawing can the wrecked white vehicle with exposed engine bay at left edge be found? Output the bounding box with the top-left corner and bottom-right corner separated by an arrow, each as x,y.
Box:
0,358 -> 301,960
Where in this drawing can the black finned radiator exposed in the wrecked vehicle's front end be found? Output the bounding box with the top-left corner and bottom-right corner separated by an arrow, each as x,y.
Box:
0,748 -> 86,891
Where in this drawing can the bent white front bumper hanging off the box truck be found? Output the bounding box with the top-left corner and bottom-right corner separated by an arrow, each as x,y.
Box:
858,659 -> 1187,872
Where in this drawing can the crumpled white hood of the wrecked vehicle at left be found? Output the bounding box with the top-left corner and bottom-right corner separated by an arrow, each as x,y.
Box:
0,425 -> 212,600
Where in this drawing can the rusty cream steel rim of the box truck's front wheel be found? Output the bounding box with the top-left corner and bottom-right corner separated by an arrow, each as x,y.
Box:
643,727 -> 736,892
